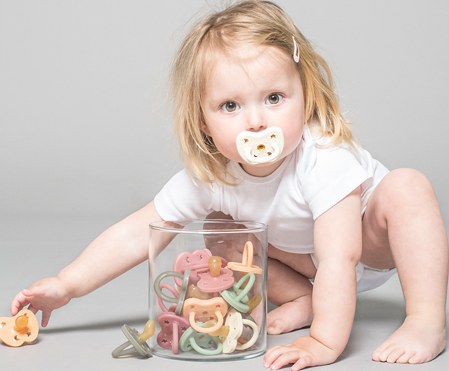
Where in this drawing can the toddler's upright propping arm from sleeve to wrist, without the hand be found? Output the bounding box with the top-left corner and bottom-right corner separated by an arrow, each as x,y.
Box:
310,188 -> 362,358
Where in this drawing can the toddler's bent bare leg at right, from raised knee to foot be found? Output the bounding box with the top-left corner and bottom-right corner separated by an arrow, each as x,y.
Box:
362,169 -> 448,363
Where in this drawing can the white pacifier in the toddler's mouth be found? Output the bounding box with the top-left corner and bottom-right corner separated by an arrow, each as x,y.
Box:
236,126 -> 284,164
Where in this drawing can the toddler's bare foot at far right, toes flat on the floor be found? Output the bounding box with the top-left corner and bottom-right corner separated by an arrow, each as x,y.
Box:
372,316 -> 446,363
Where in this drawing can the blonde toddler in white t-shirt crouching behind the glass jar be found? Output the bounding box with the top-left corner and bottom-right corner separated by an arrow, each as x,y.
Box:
12,1 -> 448,370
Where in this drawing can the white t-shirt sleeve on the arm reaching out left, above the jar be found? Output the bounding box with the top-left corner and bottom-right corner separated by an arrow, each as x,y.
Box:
154,170 -> 212,221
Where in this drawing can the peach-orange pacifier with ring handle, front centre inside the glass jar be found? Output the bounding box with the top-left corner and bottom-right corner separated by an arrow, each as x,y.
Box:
182,297 -> 228,334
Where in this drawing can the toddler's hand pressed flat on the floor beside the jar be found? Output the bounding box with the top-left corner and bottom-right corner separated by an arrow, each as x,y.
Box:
264,336 -> 340,371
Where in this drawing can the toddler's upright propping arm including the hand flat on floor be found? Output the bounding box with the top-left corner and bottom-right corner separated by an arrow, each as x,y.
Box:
264,188 -> 362,370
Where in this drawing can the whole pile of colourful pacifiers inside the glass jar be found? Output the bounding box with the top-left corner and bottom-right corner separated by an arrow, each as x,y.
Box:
154,241 -> 262,356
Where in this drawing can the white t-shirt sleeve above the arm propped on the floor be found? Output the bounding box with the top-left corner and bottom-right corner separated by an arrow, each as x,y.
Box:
299,147 -> 371,220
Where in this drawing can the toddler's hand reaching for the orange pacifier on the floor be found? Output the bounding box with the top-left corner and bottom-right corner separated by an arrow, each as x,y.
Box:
11,277 -> 71,327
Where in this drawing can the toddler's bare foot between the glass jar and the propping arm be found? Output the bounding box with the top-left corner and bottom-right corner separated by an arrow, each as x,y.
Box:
267,295 -> 312,335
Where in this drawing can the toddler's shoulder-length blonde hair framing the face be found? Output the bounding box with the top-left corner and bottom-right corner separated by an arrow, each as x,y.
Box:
171,0 -> 353,184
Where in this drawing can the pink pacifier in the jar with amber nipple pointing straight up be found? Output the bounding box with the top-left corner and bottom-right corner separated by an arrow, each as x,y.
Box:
197,256 -> 234,293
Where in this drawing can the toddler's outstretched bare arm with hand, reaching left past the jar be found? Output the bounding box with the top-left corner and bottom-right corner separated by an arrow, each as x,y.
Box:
11,202 -> 161,327
